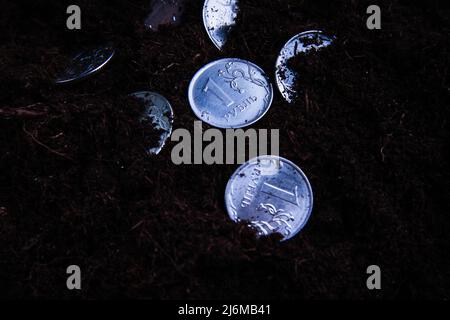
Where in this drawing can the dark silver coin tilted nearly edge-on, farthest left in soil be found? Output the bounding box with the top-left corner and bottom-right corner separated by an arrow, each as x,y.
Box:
56,46 -> 115,84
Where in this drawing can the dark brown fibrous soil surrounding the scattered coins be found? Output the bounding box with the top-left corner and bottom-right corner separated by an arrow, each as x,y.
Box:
0,0 -> 450,299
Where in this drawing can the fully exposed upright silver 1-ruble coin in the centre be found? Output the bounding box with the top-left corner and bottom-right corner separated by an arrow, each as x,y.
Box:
189,58 -> 273,128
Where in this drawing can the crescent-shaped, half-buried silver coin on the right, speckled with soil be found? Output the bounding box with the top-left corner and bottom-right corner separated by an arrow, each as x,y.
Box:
275,30 -> 333,103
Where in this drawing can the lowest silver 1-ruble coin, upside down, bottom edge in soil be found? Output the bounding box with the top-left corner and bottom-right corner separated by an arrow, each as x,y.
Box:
225,156 -> 313,240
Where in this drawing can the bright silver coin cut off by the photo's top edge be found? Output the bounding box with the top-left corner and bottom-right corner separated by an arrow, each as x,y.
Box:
203,0 -> 239,50
